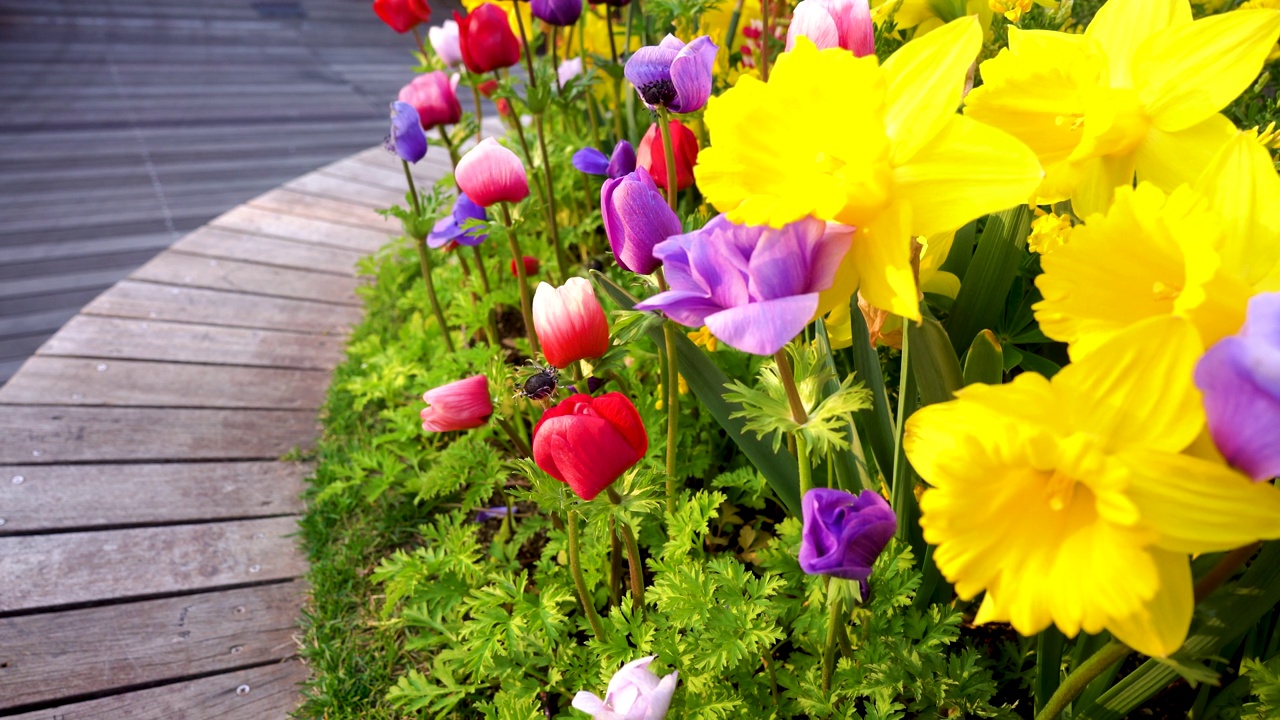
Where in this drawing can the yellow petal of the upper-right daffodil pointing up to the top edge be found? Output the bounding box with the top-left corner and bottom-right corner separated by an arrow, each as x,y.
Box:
1084,0 -> 1192,87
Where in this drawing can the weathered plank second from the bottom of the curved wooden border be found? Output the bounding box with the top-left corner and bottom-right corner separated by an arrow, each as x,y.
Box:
0,584 -> 303,717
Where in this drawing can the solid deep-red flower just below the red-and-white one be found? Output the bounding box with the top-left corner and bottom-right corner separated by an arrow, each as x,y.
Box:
534,392 -> 649,500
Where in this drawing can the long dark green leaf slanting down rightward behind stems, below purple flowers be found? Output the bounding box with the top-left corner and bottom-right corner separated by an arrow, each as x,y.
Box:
591,270 -> 800,516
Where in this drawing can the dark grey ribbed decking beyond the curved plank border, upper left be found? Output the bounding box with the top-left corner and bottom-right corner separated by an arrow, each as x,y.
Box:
0,0 -> 471,383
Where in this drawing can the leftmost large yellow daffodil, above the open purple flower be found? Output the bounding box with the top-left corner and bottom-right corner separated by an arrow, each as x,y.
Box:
694,18 -> 1042,318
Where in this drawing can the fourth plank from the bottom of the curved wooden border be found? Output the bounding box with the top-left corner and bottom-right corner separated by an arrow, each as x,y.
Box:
0,461 -> 308,532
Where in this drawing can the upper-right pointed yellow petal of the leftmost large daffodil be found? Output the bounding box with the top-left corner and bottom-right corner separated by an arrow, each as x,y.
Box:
883,17 -> 982,165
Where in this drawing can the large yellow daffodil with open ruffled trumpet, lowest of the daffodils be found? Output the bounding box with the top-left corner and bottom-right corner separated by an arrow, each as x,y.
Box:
904,316 -> 1280,656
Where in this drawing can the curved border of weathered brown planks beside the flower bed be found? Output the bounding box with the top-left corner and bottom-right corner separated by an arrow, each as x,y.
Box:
0,142 -> 458,720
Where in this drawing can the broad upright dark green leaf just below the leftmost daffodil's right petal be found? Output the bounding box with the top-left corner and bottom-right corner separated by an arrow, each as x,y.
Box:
947,205 -> 1032,355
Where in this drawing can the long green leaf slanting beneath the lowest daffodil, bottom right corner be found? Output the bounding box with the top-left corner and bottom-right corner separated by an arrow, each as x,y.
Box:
1074,542 -> 1280,720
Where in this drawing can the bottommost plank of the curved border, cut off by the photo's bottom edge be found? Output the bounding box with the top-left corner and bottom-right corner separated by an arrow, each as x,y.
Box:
10,660 -> 307,720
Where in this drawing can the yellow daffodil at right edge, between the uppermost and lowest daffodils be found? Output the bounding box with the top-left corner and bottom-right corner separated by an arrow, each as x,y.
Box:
1034,133 -> 1280,359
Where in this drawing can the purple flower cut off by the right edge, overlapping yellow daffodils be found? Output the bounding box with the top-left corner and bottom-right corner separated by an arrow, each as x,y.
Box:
1196,292 -> 1280,480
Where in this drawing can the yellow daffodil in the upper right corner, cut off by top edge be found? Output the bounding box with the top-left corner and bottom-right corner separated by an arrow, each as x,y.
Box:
965,0 -> 1280,218
